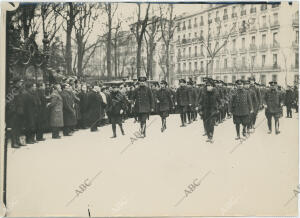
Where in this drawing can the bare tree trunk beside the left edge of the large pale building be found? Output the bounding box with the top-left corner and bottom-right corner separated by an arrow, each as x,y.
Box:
160,4 -> 176,82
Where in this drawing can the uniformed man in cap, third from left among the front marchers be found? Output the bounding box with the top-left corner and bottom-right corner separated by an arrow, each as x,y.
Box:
156,80 -> 174,132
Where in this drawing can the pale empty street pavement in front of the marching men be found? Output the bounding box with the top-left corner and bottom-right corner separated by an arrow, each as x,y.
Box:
7,112 -> 298,217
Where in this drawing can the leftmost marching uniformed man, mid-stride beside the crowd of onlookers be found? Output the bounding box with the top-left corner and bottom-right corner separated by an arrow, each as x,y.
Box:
108,85 -> 127,138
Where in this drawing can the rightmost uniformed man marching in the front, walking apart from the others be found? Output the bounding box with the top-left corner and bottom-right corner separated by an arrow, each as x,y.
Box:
265,81 -> 283,135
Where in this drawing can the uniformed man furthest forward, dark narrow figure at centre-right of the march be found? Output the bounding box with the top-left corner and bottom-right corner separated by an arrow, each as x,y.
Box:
199,78 -> 218,143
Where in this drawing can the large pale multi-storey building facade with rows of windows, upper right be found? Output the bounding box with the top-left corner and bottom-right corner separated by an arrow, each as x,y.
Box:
173,2 -> 299,86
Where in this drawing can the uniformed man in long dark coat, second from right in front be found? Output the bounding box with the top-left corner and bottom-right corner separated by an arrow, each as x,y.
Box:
230,80 -> 253,140
